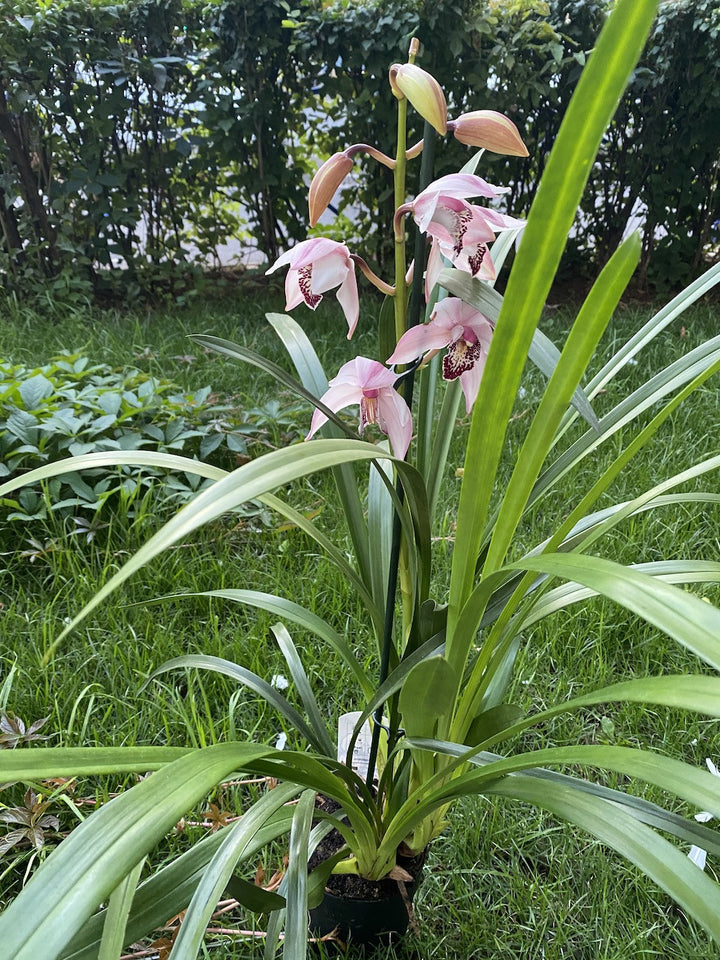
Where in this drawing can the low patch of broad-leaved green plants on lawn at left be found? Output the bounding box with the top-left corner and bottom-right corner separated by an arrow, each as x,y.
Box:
0,353 -> 302,524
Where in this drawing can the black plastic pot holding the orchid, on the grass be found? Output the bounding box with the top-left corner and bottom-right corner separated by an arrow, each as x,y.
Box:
310,878 -> 419,946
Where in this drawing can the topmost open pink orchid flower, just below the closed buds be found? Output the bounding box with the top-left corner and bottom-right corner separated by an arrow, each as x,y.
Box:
411,173 -> 523,288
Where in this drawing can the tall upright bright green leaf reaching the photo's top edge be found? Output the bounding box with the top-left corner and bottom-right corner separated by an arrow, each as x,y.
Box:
448,0 -> 657,636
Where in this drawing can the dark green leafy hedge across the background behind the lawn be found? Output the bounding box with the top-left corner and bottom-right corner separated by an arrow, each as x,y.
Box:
0,0 -> 720,296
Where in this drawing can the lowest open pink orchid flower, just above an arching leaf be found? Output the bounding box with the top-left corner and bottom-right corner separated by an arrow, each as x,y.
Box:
305,357 -> 412,460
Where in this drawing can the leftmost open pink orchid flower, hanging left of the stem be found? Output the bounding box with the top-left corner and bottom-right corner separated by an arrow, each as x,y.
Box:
266,237 -> 360,340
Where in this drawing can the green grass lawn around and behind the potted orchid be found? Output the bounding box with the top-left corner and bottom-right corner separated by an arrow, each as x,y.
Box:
0,287 -> 720,960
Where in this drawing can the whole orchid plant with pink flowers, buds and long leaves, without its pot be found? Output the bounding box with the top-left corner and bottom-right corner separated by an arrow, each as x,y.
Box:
0,0 -> 720,960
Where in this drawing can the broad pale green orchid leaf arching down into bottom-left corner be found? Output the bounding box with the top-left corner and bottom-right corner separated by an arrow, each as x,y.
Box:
0,743 -> 274,960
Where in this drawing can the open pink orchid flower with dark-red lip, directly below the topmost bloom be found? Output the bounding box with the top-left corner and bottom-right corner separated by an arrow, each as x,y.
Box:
388,297 -> 493,413
